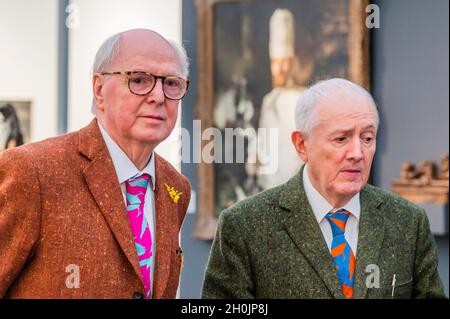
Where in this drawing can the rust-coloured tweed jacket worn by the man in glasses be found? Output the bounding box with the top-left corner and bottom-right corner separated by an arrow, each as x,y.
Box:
0,120 -> 190,298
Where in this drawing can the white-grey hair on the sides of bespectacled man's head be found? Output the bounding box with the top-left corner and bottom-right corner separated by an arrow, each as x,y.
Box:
91,32 -> 189,114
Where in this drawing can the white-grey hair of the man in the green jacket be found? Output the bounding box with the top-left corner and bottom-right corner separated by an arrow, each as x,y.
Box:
295,78 -> 380,136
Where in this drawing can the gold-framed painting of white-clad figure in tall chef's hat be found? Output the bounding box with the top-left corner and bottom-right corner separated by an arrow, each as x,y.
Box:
194,0 -> 370,240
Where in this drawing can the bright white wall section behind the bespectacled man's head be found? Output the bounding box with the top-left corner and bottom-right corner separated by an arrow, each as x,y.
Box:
67,0 -> 182,169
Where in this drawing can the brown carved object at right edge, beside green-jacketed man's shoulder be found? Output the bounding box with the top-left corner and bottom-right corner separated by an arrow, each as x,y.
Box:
391,154 -> 449,205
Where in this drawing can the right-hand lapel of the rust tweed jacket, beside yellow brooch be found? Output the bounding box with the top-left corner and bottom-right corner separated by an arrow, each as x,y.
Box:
153,153 -> 177,299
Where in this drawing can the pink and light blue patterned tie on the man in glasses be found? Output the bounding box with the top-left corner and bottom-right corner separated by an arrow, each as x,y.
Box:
125,174 -> 153,299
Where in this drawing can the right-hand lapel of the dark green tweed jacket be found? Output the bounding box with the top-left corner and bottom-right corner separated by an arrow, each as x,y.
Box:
353,186 -> 385,299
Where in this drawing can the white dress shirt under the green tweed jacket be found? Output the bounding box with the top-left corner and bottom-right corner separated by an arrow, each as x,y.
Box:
303,165 -> 361,257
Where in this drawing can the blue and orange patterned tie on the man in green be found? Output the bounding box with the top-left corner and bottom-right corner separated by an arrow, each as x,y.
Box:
325,209 -> 356,298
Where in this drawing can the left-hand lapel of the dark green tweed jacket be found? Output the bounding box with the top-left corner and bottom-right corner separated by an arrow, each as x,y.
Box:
279,166 -> 343,298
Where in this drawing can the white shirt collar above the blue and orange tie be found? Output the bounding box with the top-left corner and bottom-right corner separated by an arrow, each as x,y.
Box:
303,164 -> 361,224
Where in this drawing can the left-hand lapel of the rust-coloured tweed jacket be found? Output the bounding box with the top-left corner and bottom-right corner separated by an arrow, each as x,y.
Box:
79,119 -> 141,284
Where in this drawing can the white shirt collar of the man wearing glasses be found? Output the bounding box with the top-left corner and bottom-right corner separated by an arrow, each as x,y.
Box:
97,122 -> 156,190
